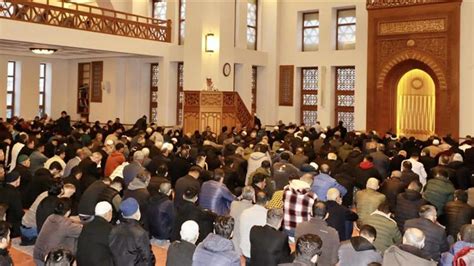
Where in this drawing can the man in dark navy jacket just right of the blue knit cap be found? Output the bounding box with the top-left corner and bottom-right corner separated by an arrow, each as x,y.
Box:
147,182 -> 176,240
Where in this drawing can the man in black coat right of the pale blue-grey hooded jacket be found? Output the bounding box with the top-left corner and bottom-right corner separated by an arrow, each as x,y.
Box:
250,209 -> 293,266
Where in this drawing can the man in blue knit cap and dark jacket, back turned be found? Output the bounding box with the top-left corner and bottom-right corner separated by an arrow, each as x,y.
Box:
109,198 -> 155,266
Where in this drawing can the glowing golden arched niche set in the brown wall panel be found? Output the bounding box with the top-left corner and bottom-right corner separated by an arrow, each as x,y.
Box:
396,69 -> 436,139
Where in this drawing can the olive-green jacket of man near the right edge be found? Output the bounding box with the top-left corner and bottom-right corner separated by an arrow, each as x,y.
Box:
423,177 -> 455,216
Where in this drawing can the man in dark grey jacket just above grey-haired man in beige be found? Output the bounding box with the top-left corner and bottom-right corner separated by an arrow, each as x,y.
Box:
405,205 -> 449,261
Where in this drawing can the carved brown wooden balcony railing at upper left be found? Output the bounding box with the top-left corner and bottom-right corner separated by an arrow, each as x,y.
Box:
0,0 -> 171,42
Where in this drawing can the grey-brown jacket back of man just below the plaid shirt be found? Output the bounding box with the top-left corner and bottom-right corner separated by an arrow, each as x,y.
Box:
295,218 -> 339,266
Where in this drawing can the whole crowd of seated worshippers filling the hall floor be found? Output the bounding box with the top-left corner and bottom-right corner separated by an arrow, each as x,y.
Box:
0,112 -> 474,266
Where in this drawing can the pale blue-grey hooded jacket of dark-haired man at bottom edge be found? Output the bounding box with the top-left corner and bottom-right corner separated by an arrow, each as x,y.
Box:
193,234 -> 240,266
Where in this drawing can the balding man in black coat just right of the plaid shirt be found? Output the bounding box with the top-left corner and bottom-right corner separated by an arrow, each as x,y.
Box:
326,188 -> 359,241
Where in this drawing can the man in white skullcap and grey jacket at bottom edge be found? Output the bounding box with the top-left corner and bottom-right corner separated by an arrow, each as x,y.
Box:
166,220 -> 199,266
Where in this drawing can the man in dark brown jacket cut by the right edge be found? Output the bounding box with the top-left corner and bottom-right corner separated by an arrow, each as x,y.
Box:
444,189 -> 474,239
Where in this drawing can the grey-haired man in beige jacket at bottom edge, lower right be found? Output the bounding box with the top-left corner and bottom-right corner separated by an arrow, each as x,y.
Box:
382,228 -> 436,266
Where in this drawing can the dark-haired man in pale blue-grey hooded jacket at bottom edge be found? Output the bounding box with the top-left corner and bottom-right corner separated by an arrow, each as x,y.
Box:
193,216 -> 240,266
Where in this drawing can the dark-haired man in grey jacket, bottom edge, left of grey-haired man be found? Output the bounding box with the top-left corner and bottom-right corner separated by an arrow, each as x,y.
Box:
339,225 -> 382,266
